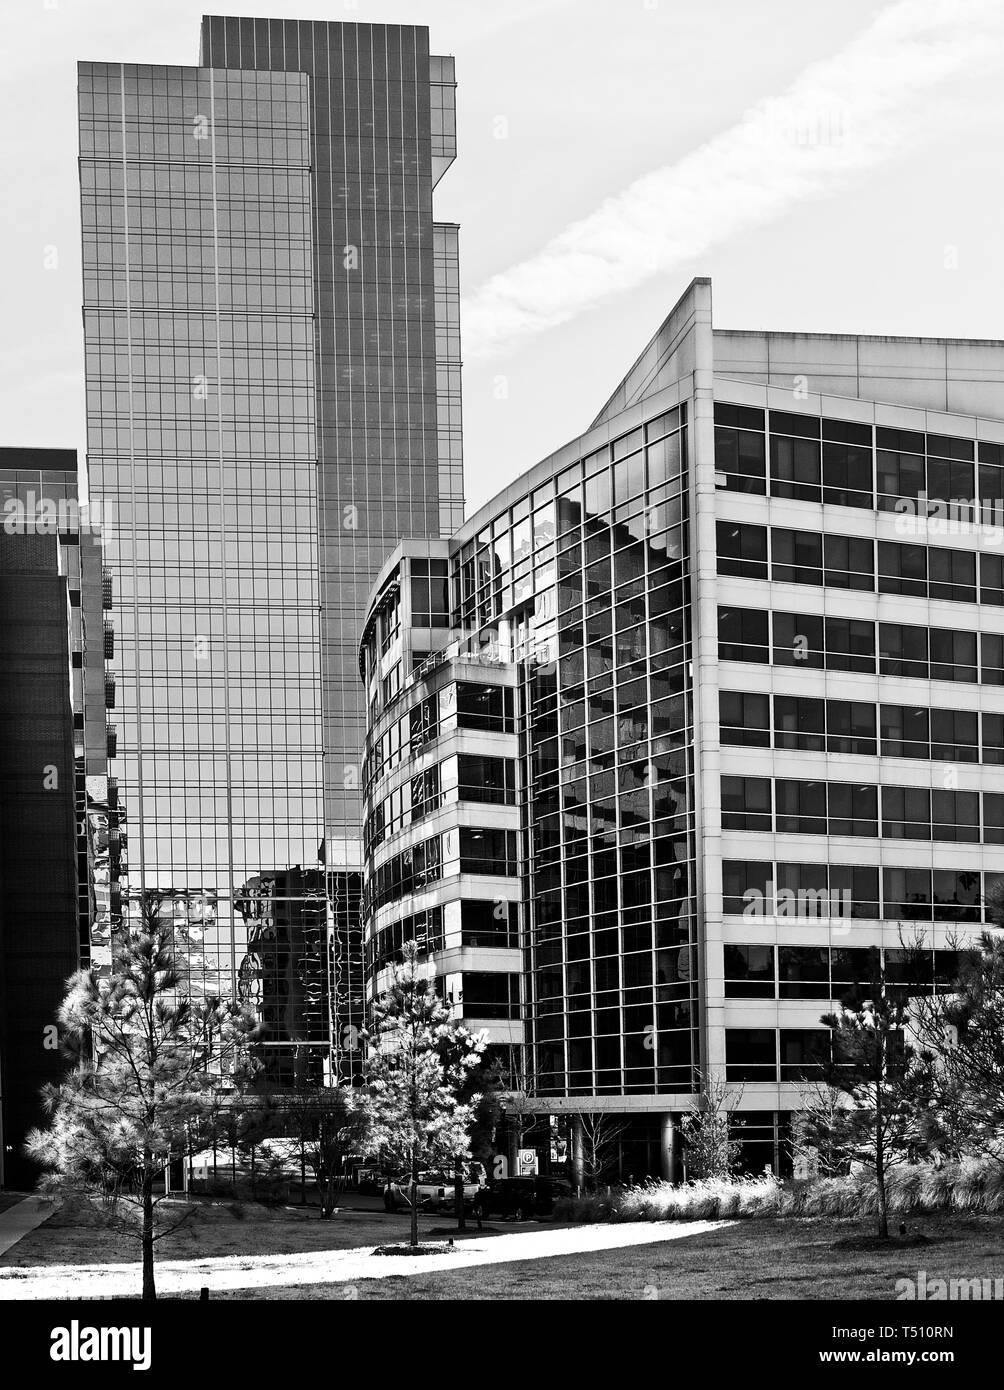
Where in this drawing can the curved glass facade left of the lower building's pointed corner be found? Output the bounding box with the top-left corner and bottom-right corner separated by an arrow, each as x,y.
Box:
362,403 -> 699,1099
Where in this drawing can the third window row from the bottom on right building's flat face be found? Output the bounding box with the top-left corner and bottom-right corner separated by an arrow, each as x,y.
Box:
722,859 -> 984,922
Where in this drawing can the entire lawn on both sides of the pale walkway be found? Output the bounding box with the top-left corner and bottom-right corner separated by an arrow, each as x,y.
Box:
7,1205 -> 1004,1300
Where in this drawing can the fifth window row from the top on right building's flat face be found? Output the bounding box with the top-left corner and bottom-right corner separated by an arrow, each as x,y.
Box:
722,777 -> 1004,845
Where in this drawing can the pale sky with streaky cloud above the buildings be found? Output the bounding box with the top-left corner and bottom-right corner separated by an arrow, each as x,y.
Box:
0,0 -> 1004,514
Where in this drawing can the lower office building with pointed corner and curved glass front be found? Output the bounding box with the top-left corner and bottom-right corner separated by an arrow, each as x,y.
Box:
360,279 -> 1004,1176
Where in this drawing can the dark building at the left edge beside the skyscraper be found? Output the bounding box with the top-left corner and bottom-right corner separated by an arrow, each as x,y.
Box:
0,448 -> 117,1188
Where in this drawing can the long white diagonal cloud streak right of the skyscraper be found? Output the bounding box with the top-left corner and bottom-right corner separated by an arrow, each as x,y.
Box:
463,0 -> 1004,357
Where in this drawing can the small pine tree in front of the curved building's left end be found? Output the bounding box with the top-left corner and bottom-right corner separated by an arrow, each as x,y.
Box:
367,941 -> 485,1247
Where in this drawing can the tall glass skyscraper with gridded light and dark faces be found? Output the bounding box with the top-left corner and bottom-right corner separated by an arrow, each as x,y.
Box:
79,18 -> 463,1080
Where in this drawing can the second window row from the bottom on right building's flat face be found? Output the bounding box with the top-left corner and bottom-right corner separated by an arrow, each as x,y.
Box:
724,942 -> 960,999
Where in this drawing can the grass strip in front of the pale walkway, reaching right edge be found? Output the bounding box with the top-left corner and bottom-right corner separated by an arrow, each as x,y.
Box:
197,1212 -> 1004,1301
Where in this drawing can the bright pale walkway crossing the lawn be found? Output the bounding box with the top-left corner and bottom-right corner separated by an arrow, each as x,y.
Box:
0,1220 -> 731,1300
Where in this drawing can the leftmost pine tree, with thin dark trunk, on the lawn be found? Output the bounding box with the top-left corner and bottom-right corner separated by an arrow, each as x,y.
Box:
26,895 -> 256,1300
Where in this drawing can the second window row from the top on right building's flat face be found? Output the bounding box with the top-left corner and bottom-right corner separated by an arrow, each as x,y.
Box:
718,521 -> 1004,607
